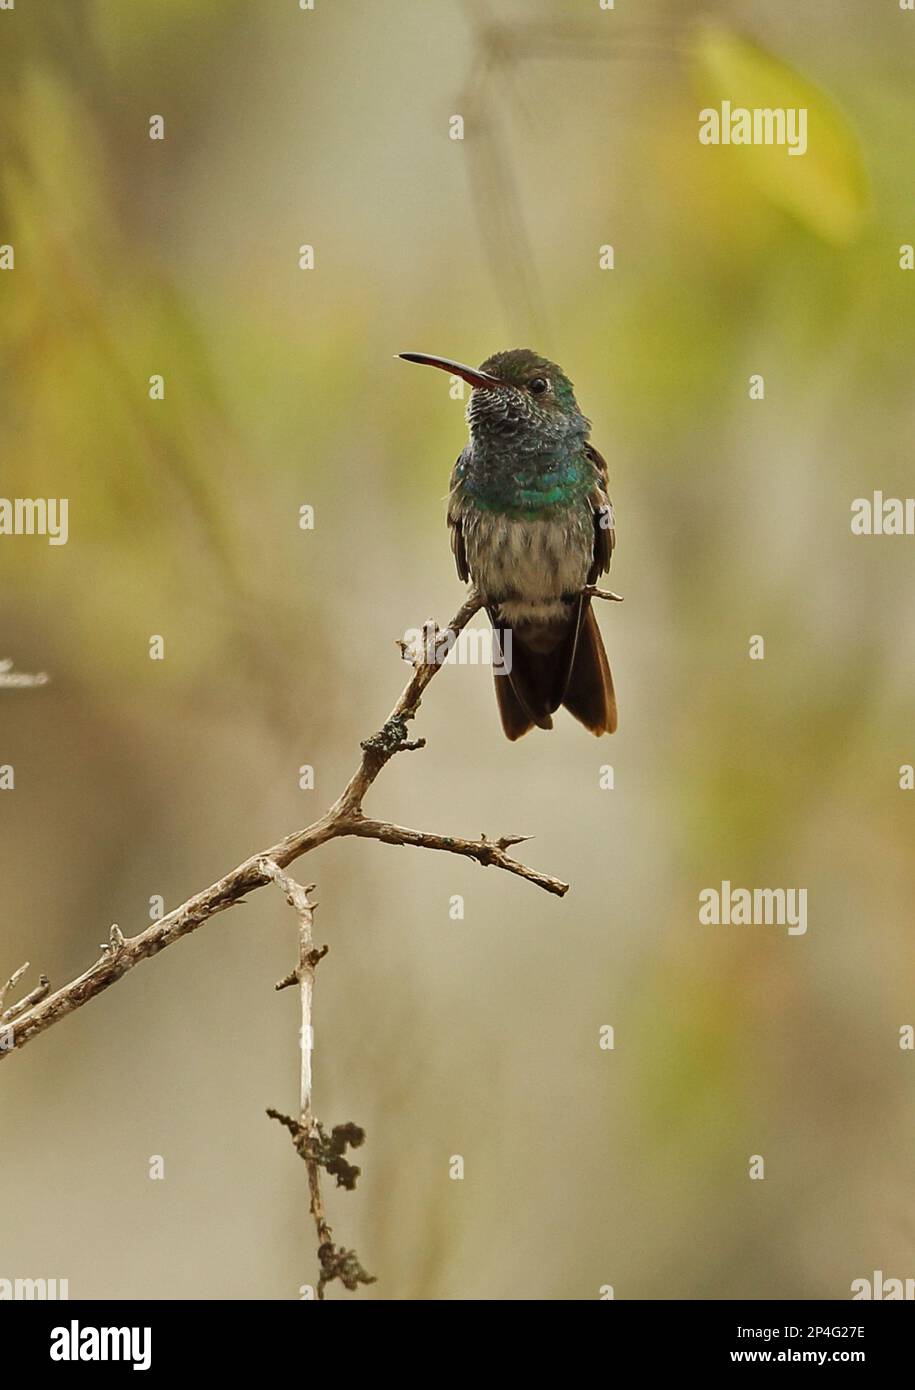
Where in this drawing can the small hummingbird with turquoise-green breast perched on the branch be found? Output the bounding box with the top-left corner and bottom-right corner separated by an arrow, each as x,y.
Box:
399,348 -> 616,739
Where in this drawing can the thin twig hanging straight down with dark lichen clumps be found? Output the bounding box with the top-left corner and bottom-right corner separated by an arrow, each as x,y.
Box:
261,859 -> 375,1298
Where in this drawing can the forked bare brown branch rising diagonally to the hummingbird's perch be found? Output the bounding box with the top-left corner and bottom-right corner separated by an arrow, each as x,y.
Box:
0,591 -> 569,1061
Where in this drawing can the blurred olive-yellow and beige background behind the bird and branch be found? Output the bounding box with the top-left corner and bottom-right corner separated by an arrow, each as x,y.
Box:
0,0 -> 915,1300
